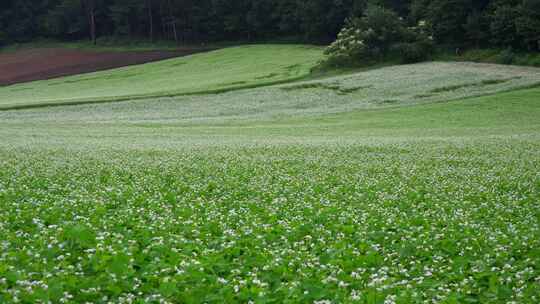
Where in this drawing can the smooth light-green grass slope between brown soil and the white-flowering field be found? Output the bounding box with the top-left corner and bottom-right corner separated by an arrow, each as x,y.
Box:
0,45 -> 322,109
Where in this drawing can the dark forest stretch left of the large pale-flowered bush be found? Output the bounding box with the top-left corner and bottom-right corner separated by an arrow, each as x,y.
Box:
0,0 -> 363,43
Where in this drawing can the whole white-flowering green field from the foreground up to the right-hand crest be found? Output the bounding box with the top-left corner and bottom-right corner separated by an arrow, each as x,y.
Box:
0,45 -> 540,304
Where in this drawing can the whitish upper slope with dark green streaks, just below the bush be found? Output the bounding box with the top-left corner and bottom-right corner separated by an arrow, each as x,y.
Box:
0,63 -> 540,124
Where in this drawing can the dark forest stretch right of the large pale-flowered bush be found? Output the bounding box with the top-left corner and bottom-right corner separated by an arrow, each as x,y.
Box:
408,0 -> 540,51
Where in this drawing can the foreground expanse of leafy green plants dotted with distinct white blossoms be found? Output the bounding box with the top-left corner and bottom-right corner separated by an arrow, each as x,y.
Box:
0,139 -> 540,303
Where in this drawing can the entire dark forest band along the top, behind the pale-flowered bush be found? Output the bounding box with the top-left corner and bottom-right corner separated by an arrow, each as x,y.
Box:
0,0 -> 540,50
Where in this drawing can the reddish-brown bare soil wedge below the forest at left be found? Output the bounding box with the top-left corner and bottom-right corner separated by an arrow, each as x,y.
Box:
0,48 -> 208,86
